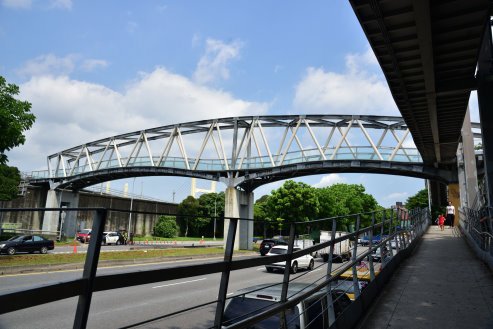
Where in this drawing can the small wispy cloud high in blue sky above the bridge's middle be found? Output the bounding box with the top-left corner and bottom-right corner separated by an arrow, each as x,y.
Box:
194,37 -> 242,84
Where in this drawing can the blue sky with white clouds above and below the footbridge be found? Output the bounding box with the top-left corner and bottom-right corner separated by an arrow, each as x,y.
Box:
0,0 -> 478,206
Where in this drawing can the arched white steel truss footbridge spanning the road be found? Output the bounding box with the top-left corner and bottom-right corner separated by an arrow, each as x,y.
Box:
31,115 -> 455,192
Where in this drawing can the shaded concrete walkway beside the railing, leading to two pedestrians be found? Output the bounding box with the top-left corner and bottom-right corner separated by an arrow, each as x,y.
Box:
357,226 -> 493,329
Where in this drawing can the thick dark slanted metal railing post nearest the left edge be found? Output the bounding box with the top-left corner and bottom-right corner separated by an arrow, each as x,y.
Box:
74,209 -> 107,329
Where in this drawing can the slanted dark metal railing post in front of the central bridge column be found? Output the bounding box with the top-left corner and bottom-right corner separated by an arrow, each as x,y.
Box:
214,218 -> 238,328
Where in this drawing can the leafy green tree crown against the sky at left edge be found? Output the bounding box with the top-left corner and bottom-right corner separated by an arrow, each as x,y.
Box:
0,76 -> 36,165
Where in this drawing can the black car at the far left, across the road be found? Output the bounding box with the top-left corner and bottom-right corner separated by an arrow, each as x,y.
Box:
0,235 -> 55,255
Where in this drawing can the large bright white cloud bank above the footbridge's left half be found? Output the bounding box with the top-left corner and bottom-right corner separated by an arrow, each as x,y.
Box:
8,68 -> 268,170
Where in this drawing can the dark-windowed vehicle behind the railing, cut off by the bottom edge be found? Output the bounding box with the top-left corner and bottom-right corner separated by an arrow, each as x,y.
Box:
223,282 -> 351,329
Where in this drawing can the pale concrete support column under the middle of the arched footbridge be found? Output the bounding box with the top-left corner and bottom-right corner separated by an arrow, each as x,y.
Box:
224,187 -> 254,250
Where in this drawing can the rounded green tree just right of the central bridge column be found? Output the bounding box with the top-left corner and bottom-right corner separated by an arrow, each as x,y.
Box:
266,180 -> 319,229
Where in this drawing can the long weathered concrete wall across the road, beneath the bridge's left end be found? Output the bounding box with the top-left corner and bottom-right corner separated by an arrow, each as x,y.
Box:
0,186 -> 178,237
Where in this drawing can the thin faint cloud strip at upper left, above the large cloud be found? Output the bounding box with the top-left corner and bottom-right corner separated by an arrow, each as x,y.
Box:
17,54 -> 108,77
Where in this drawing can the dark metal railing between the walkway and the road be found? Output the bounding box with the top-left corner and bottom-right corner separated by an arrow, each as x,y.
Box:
0,208 -> 430,328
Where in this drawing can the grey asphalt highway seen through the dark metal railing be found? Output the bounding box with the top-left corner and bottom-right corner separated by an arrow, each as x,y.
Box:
0,260 -> 338,328
